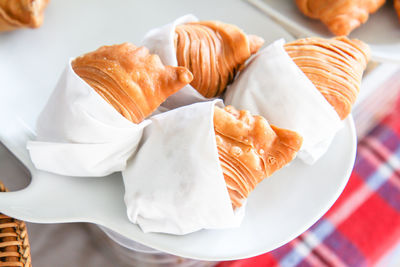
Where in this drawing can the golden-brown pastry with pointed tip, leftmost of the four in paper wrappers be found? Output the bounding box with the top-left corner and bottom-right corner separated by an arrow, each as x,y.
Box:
72,43 -> 193,123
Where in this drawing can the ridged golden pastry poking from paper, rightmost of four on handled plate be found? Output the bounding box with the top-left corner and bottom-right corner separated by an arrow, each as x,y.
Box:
285,37 -> 370,120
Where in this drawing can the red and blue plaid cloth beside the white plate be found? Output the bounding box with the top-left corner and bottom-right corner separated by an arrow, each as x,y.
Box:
217,95 -> 400,267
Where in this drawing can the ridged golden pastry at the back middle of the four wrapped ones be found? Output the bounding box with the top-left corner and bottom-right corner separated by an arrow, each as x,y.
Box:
175,21 -> 264,98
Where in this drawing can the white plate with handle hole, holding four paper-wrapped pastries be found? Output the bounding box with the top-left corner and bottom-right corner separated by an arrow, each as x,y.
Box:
0,0 -> 356,260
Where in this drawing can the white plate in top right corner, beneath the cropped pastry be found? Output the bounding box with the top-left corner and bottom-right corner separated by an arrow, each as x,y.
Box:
247,0 -> 400,63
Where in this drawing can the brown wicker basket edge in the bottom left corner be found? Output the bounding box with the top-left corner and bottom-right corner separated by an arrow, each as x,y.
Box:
0,182 -> 32,267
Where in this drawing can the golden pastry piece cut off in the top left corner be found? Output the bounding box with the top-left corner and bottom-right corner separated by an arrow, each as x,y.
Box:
0,0 -> 49,32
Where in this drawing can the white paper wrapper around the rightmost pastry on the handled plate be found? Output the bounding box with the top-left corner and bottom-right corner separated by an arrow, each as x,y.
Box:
225,40 -> 342,164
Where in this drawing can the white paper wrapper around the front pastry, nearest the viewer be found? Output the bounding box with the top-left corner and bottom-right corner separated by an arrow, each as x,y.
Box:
122,101 -> 244,235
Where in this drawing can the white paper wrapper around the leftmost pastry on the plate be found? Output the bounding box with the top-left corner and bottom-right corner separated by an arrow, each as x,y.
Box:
27,61 -> 150,176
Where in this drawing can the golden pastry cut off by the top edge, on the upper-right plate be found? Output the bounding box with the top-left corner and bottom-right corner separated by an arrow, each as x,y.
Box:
296,0 -> 385,35
